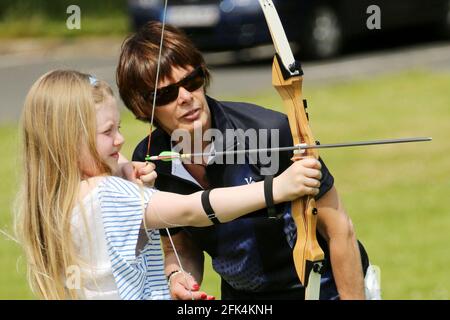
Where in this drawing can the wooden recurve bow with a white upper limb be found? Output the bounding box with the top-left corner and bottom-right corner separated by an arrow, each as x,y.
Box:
259,0 -> 324,300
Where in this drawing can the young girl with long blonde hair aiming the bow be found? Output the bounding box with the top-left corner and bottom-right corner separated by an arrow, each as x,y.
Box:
16,71 -> 321,299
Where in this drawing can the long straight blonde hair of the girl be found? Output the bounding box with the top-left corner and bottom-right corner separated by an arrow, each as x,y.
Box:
16,70 -> 113,299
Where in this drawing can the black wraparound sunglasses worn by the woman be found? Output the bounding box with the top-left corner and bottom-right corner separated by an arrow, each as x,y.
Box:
147,66 -> 205,107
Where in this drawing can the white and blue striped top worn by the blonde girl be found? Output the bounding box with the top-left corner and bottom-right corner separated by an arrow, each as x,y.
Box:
72,177 -> 170,300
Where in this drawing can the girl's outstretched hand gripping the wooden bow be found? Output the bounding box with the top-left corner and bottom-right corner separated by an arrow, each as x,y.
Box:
273,158 -> 322,203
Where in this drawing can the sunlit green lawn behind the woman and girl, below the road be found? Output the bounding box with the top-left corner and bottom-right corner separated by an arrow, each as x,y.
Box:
0,71 -> 450,299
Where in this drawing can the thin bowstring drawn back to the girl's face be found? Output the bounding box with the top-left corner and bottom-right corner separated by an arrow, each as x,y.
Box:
144,0 -> 195,300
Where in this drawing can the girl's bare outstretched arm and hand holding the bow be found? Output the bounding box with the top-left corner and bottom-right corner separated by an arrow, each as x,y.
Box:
145,158 -> 321,229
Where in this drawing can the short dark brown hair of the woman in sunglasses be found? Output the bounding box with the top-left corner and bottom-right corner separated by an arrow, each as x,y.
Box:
116,21 -> 210,121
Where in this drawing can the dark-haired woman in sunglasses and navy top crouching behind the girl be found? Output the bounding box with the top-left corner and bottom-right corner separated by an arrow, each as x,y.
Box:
117,22 -> 368,299
